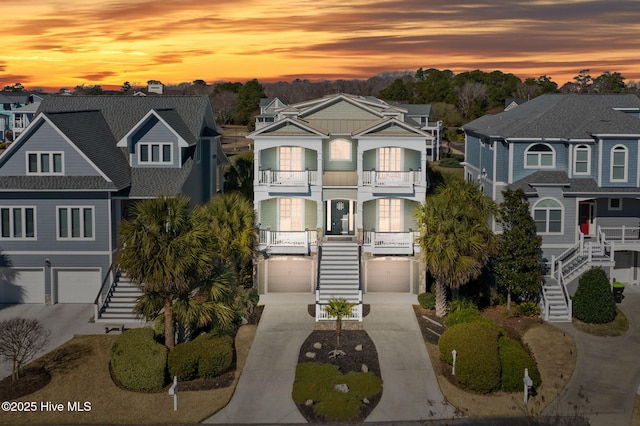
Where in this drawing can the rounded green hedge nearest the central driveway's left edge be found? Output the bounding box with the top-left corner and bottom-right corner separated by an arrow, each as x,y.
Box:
168,334 -> 233,381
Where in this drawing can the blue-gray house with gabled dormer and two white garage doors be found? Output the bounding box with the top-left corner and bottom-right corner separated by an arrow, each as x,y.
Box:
0,96 -> 227,310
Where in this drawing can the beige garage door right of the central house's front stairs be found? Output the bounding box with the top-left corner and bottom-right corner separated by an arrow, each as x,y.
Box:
365,257 -> 412,293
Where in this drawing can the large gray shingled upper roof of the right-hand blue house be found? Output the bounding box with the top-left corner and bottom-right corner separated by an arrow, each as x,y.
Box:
464,94 -> 640,140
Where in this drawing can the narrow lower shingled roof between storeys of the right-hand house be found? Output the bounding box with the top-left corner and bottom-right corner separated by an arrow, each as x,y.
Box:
507,171 -> 640,195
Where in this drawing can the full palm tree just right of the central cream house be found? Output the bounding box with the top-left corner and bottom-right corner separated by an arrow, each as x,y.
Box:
415,179 -> 497,317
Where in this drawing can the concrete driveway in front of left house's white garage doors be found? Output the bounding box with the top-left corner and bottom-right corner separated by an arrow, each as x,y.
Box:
0,303 -> 104,378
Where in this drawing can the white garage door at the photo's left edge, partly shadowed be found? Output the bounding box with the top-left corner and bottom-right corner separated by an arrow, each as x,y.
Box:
0,268 -> 44,304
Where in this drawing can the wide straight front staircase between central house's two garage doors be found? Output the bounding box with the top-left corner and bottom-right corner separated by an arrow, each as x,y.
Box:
316,241 -> 362,305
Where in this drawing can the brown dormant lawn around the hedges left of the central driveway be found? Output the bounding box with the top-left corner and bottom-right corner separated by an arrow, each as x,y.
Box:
0,325 -> 256,424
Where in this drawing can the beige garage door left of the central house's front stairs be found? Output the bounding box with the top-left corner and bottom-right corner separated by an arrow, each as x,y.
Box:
266,258 -> 314,293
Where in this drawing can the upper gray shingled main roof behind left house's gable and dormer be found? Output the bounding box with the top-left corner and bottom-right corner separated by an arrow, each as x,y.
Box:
38,96 -> 220,144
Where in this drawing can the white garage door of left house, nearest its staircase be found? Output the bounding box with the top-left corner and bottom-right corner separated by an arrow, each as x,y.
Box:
54,269 -> 102,303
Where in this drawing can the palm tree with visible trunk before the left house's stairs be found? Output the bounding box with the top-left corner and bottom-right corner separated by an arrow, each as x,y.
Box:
118,196 -> 212,349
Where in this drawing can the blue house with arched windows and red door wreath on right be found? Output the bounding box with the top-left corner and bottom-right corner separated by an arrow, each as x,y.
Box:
464,94 -> 640,320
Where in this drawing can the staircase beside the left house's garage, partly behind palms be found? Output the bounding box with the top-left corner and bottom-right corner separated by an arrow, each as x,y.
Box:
97,272 -> 142,322
